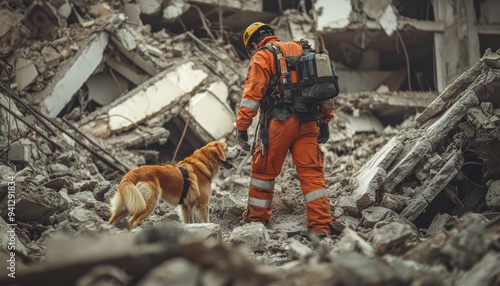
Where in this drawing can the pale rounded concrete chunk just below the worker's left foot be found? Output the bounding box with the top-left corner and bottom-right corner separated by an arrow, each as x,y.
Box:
229,222 -> 270,251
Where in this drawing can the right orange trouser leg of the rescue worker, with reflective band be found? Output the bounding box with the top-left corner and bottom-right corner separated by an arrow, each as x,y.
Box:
290,119 -> 332,233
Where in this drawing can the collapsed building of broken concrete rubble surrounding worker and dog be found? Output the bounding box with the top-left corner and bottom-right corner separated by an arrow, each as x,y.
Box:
0,0 -> 500,285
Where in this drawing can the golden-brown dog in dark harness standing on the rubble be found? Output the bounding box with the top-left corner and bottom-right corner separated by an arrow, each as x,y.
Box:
109,141 -> 241,229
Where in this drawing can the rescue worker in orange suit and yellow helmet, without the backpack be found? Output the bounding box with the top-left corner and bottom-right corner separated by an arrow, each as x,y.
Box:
236,22 -> 333,238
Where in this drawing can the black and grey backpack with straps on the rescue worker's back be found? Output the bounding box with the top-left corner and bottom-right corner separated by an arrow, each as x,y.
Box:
262,39 -> 339,105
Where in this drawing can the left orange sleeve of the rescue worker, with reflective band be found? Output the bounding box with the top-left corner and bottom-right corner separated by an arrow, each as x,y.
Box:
236,50 -> 274,131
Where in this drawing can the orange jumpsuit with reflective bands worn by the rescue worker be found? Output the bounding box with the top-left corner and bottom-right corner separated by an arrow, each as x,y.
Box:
236,36 -> 333,234
